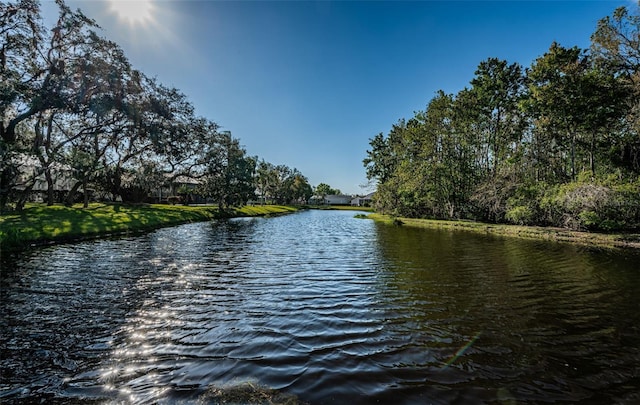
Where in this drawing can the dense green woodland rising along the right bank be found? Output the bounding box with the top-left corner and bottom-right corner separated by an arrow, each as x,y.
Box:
364,3 -> 640,231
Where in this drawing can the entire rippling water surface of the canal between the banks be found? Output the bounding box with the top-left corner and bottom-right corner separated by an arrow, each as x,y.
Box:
0,211 -> 640,404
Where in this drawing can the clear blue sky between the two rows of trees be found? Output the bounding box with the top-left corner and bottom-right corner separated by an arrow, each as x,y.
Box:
43,0 -> 633,194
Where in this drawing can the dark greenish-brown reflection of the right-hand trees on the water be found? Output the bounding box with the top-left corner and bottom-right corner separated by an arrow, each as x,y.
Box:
378,227 -> 640,403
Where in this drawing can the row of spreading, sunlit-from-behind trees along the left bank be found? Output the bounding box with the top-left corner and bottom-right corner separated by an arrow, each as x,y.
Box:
0,0 -> 312,212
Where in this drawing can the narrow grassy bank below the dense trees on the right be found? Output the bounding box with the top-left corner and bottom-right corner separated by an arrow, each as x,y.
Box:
367,214 -> 640,249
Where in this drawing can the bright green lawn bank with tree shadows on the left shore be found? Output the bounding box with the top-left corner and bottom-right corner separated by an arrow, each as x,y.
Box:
0,204 -> 297,248
